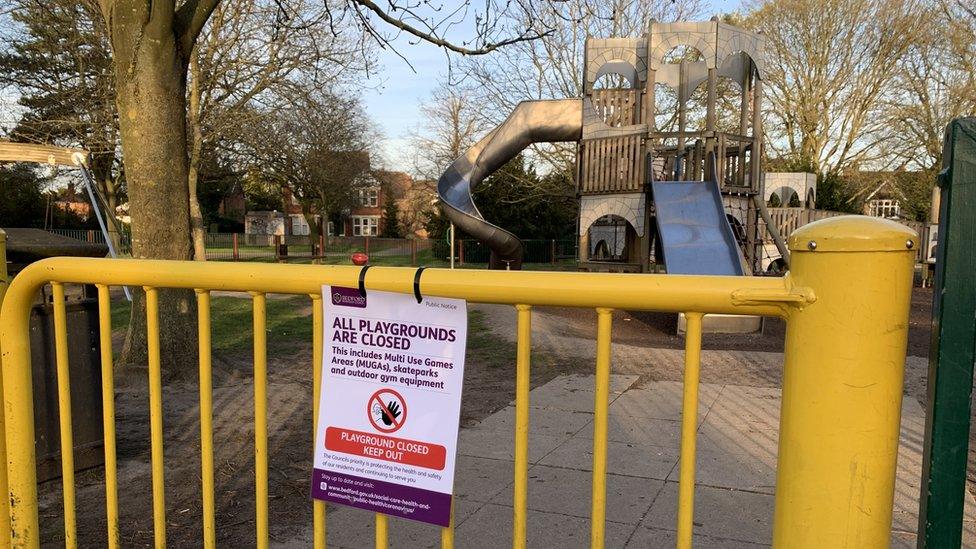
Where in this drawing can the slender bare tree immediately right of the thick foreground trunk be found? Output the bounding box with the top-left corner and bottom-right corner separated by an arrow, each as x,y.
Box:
187,0 -> 371,260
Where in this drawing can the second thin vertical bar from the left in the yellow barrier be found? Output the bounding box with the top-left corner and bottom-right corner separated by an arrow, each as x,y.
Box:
98,284 -> 119,549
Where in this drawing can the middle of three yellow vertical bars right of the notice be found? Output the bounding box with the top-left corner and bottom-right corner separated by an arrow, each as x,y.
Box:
590,308 -> 613,549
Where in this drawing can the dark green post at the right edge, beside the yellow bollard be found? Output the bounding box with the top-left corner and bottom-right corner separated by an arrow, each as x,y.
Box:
918,118 -> 976,549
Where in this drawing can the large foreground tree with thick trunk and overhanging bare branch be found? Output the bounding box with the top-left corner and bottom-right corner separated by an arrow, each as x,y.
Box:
99,0 -> 564,375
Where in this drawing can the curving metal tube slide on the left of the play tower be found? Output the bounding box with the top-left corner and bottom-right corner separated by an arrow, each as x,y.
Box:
437,99 -> 583,269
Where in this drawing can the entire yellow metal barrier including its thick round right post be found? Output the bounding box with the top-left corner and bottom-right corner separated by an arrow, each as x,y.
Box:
0,217 -> 918,548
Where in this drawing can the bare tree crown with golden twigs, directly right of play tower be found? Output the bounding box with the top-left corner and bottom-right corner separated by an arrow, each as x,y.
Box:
746,0 -> 925,174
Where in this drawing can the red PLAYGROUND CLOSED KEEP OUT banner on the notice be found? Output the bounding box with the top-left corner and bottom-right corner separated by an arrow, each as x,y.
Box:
325,427 -> 447,471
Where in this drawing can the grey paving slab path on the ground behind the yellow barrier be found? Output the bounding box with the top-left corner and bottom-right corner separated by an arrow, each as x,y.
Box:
282,375 -> 976,548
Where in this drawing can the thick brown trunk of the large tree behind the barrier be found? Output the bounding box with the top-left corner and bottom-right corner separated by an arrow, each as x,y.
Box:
112,19 -> 197,379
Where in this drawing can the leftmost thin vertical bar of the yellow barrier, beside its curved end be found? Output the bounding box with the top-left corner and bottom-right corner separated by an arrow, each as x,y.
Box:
51,282 -> 78,548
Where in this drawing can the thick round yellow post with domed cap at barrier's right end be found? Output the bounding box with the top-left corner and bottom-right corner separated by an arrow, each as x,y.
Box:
773,216 -> 918,549
